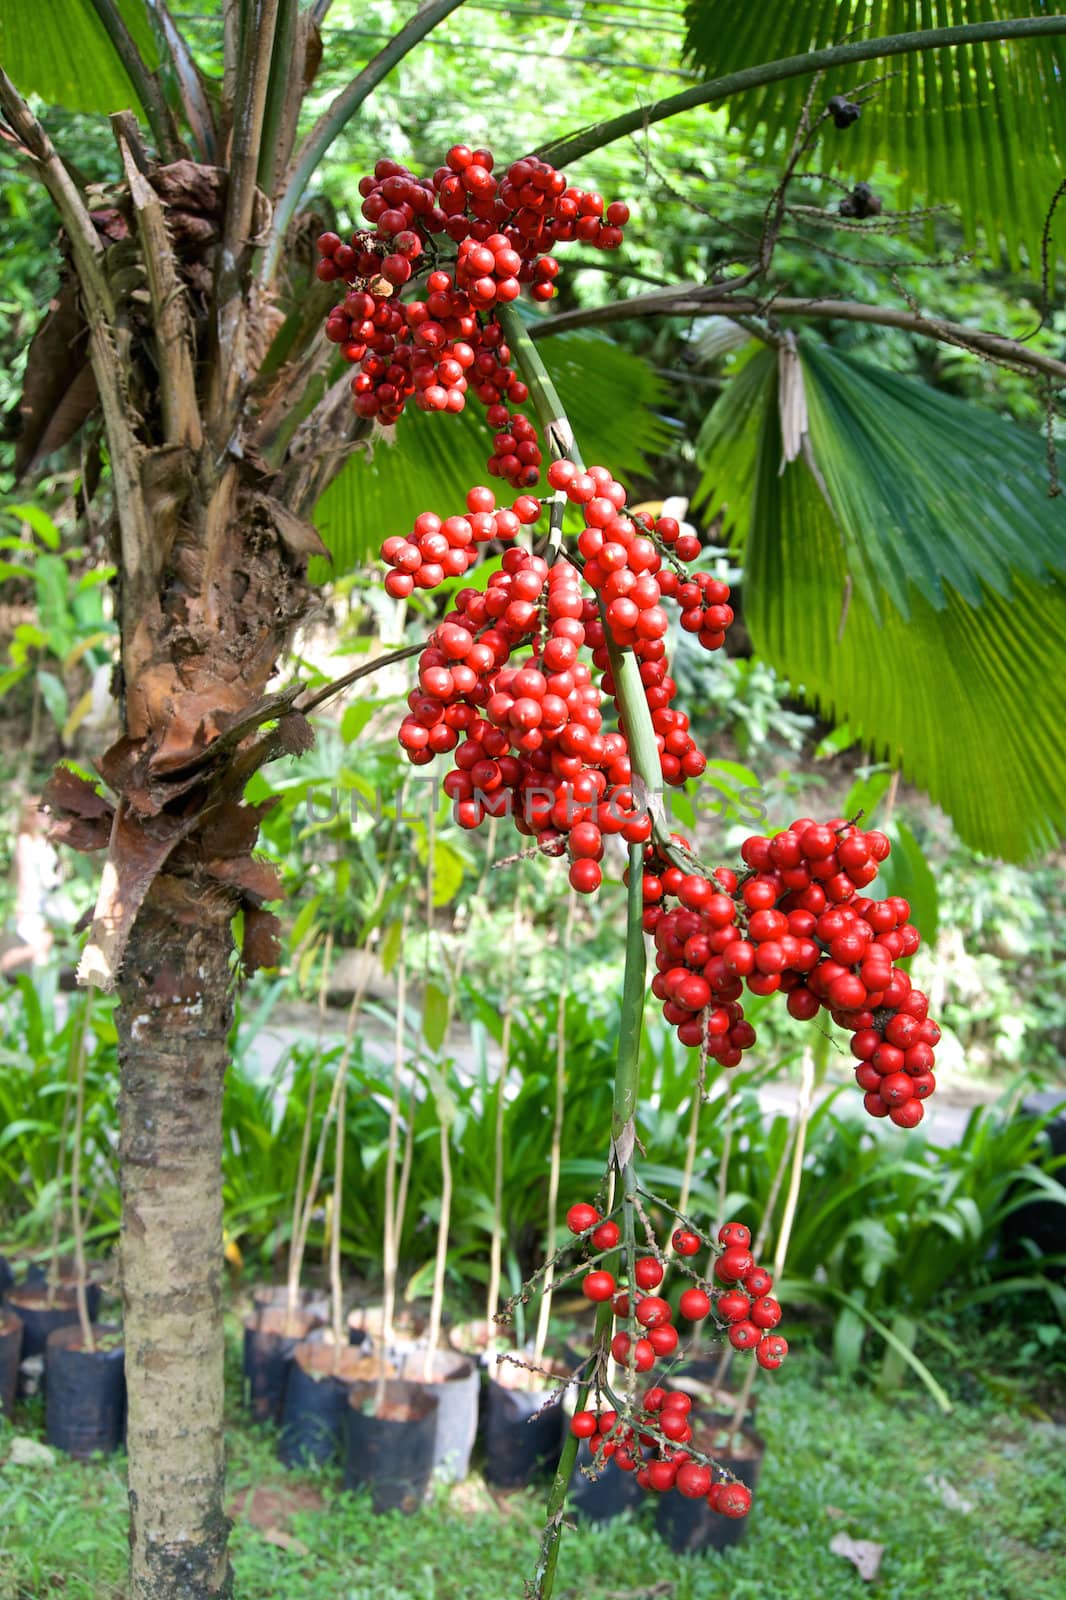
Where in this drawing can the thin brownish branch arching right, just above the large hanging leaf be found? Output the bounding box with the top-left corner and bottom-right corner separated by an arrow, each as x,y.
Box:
530,283 -> 1066,384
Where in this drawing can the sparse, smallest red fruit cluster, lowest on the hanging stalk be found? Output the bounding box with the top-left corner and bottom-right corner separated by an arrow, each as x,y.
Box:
567,1203 -> 789,1517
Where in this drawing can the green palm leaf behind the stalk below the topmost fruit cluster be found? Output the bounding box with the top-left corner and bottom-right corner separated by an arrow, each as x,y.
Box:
312,333 -> 669,581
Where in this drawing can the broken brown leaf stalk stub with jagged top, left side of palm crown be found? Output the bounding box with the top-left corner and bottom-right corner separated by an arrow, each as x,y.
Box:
110,112 -> 203,450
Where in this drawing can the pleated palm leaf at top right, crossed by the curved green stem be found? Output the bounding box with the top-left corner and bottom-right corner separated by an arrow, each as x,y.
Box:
685,0 -> 1066,261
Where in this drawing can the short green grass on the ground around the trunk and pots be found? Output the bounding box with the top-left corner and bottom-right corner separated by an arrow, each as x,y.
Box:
0,1352 -> 1066,1600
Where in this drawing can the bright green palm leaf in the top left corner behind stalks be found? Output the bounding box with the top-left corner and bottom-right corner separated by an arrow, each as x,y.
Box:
0,0 -> 158,112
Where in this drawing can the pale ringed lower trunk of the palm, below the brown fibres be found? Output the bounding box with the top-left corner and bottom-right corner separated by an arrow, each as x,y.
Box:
117,877 -> 232,1600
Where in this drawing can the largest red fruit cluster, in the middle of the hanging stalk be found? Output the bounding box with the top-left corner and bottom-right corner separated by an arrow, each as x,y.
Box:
381,462 -> 731,893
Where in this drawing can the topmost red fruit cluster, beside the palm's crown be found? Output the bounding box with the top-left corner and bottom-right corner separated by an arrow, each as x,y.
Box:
317,144 -> 629,488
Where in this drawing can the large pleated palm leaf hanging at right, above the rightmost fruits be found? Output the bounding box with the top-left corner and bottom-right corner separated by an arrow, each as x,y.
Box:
699,346 -> 1066,859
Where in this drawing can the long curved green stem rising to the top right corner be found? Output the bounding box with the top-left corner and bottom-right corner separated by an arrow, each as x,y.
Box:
536,16 -> 1066,166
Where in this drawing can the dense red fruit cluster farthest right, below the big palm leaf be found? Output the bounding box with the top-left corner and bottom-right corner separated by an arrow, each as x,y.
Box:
643,818 -> 940,1128
